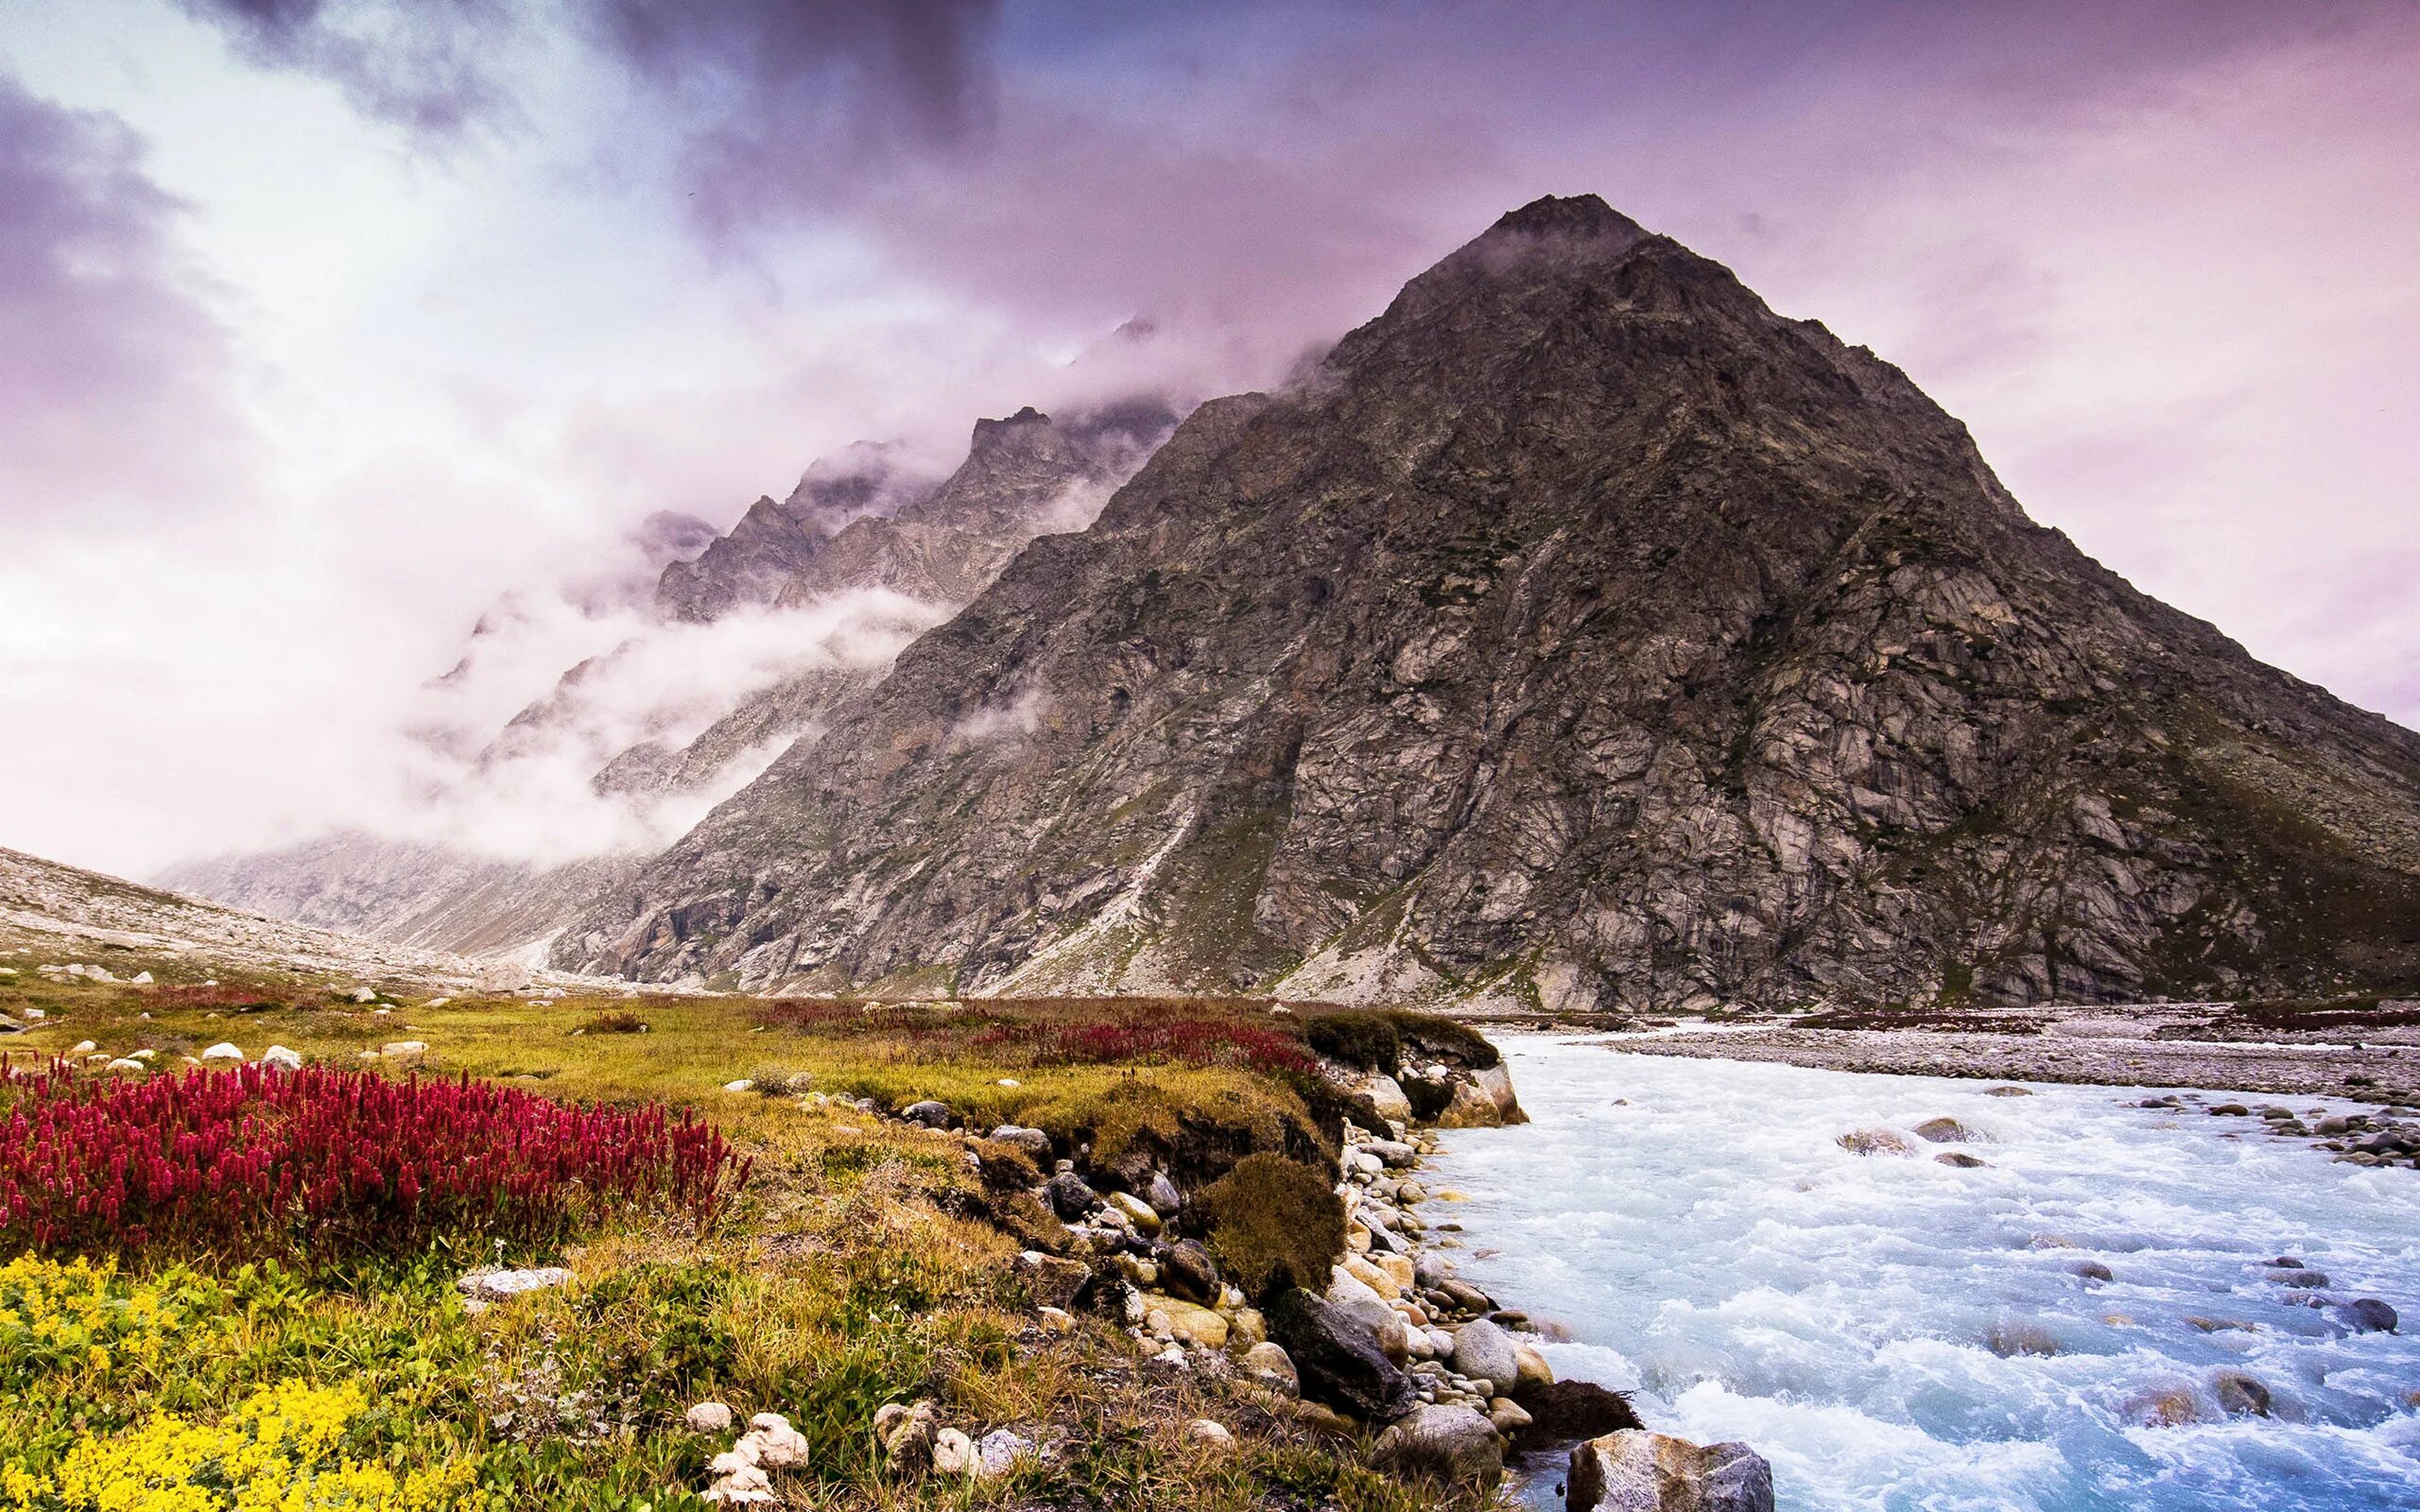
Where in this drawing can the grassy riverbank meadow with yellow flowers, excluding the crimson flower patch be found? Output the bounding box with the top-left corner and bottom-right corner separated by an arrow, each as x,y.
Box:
0,960 -> 1480,1512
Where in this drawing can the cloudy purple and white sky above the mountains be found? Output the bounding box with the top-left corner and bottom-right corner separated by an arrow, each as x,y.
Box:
0,0 -> 2420,876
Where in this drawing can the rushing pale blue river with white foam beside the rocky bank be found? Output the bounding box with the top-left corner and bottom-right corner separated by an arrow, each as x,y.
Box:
1423,1036 -> 2420,1512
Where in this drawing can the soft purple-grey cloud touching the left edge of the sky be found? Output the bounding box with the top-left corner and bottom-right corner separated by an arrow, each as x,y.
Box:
0,75 -> 251,532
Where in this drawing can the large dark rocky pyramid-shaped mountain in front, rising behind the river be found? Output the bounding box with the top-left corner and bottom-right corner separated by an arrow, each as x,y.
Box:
554,196 -> 2420,1009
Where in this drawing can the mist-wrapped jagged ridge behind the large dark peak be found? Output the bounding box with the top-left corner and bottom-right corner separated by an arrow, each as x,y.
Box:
157,397 -> 1176,955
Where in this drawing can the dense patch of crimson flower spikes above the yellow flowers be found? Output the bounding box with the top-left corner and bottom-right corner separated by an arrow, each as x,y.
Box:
0,1064 -> 748,1261
